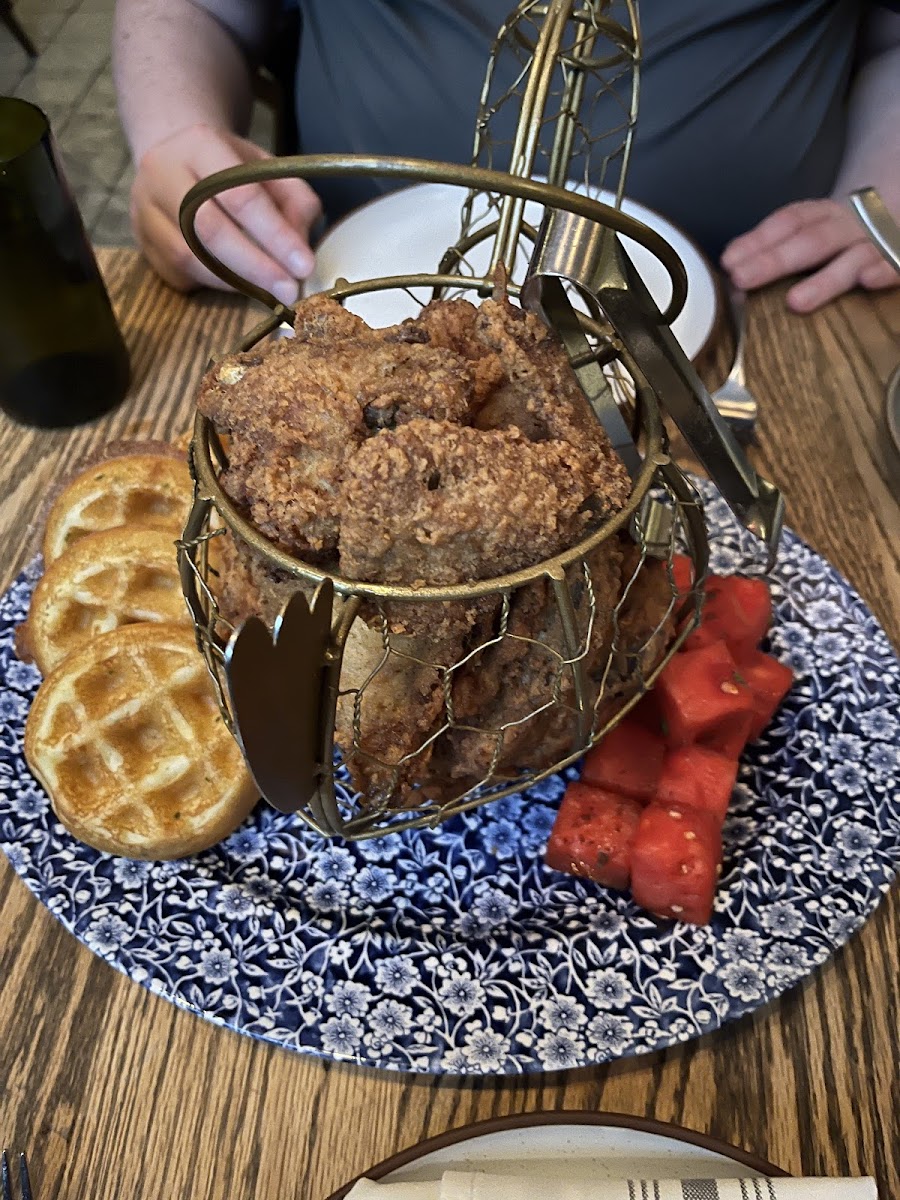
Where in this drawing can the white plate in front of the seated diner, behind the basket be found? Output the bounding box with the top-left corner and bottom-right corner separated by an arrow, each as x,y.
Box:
306,184 -> 718,359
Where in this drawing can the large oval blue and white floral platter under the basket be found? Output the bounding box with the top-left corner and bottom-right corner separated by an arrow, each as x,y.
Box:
0,487 -> 900,1074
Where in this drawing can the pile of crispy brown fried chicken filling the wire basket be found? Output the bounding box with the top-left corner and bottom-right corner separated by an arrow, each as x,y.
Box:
204,287 -> 655,803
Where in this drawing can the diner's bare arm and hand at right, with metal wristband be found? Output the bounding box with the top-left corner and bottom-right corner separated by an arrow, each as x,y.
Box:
721,7 -> 900,312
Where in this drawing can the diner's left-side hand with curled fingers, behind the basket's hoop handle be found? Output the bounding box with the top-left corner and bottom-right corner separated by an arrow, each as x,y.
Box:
131,125 -> 322,304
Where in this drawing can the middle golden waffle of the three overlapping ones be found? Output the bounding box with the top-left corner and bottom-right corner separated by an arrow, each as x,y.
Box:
24,526 -> 190,674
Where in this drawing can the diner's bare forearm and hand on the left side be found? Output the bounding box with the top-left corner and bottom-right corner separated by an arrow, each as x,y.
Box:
113,0 -> 319,304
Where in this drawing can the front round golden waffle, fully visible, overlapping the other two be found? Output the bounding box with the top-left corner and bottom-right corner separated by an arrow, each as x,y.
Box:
25,624 -> 258,859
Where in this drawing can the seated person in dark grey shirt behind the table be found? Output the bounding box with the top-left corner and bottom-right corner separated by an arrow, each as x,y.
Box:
114,0 -> 900,311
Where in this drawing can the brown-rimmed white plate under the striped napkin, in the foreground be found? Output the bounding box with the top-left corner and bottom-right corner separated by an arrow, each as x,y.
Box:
330,1112 -> 781,1200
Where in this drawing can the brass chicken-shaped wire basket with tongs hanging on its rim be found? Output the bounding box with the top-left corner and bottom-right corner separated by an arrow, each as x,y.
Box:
174,0 -> 782,838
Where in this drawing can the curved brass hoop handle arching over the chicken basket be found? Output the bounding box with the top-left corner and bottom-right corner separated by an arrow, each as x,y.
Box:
180,155 -> 688,324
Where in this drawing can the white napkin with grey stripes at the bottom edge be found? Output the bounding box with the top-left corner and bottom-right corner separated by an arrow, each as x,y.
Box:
347,1171 -> 878,1200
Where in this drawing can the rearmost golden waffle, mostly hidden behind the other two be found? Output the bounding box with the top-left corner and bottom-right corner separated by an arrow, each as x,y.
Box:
43,454 -> 192,563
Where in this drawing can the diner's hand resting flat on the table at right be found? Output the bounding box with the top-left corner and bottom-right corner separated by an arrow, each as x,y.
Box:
721,200 -> 900,312
